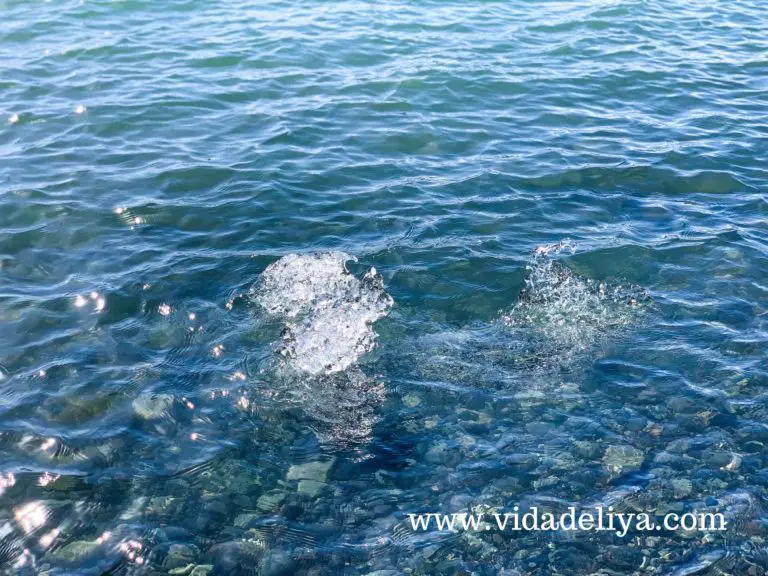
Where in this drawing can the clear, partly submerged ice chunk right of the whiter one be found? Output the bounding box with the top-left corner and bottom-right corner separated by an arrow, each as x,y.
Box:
398,242 -> 650,390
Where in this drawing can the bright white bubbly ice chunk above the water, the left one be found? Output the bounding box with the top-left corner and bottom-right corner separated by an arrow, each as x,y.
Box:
252,252 -> 394,374
